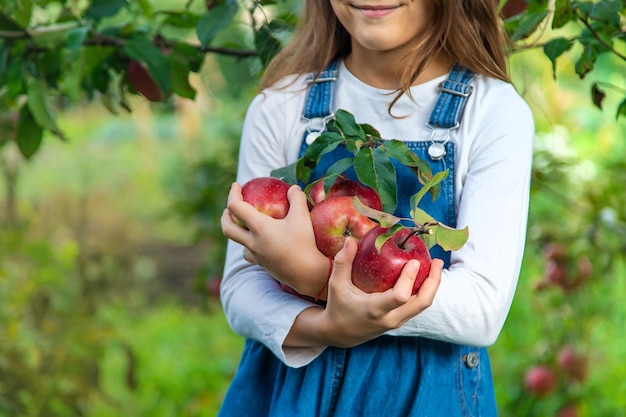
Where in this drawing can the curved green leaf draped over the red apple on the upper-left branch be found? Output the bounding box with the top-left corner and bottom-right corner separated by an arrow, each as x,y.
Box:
124,35 -> 172,95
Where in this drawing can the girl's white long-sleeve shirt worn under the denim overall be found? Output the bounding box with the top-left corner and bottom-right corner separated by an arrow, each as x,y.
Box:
221,60 -> 534,367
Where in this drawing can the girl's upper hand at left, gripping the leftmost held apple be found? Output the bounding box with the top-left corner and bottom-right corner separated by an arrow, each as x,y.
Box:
221,183 -> 329,297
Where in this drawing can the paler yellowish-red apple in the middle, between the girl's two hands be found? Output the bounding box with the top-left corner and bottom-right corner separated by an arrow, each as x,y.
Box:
311,196 -> 376,258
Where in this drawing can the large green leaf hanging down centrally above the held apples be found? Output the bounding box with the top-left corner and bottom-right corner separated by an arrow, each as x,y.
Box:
354,148 -> 398,213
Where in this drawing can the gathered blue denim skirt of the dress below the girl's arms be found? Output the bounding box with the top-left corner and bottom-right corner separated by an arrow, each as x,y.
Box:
219,336 -> 497,417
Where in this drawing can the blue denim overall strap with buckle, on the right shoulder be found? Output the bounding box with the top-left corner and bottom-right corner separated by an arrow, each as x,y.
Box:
428,64 -> 475,129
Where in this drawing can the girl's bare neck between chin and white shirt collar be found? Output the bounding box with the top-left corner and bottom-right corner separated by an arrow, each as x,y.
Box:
345,51 -> 452,90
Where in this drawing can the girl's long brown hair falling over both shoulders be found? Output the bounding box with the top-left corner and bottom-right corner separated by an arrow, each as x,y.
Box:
260,0 -> 509,94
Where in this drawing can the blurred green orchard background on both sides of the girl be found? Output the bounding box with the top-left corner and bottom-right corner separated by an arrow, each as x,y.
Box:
0,0 -> 626,417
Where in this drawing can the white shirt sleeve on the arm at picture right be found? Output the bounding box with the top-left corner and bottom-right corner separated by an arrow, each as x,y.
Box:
389,81 -> 534,346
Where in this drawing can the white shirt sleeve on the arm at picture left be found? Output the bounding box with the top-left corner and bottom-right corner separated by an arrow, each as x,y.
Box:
220,88 -> 324,367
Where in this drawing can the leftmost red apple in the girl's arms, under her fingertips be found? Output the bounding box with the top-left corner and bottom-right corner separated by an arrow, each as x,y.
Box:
232,177 -> 291,227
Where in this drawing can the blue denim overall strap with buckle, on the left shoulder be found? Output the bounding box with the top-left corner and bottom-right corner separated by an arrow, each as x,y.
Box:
302,60 -> 340,132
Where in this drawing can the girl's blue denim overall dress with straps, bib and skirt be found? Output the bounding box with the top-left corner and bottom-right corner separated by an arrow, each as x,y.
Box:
219,63 -> 497,417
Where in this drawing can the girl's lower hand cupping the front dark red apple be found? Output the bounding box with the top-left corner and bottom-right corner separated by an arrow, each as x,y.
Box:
285,238 -> 443,347
